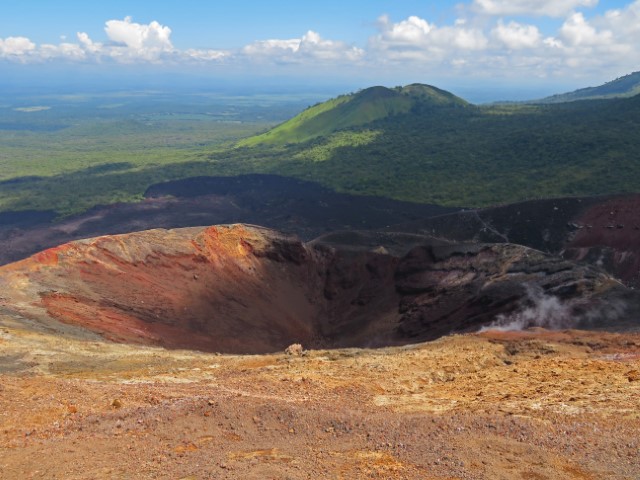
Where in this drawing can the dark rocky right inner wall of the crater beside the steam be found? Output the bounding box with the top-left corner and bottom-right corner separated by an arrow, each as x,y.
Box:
395,244 -> 626,340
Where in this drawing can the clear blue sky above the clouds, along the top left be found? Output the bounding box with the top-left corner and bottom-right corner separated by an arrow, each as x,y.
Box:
0,0 -> 456,48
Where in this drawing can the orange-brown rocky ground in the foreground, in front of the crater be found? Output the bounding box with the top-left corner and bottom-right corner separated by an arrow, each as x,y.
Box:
0,315 -> 640,480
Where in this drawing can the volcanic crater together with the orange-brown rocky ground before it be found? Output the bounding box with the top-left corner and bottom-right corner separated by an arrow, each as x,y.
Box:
0,225 -> 640,480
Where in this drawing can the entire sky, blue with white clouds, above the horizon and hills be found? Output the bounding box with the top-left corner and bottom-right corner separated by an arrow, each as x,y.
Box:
0,0 -> 640,98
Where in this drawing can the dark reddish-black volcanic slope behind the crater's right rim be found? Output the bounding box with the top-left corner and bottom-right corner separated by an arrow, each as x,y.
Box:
387,194 -> 640,287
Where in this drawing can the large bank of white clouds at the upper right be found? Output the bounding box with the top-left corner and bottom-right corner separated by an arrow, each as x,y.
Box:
367,0 -> 640,78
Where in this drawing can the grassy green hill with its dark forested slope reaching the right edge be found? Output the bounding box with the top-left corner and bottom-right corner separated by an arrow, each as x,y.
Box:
229,85 -> 640,207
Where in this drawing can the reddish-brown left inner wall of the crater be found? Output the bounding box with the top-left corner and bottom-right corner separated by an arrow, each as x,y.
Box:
0,225 -> 397,352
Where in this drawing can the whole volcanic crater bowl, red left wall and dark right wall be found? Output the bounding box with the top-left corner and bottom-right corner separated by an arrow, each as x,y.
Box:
0,225 -> 636,353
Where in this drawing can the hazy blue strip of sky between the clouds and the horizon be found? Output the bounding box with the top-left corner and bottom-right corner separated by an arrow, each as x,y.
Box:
0,68 -> 592,103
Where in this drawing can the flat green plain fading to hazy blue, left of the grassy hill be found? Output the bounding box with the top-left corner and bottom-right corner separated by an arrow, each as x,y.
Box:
0,92 -> 317,215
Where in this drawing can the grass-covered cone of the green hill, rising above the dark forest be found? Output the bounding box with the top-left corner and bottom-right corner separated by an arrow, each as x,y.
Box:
239,84 -> 467,147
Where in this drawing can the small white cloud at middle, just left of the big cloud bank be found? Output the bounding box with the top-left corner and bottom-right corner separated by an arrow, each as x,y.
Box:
242,30 -> 364,63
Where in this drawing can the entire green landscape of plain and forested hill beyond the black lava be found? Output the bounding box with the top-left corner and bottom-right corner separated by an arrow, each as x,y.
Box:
0,85 -> 640,215
